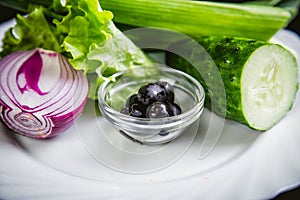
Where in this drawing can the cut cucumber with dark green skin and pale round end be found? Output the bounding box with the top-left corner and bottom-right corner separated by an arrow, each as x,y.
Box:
166,36 -> 298,131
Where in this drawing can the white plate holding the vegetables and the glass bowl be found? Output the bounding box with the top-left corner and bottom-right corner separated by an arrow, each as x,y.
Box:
0,21 -> 300,200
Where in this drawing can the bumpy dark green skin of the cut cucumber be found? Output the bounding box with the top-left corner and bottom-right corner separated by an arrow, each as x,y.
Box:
166,36 -> 267,126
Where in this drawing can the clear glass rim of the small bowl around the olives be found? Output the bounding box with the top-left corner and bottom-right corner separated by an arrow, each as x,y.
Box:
97,65 -> 205,125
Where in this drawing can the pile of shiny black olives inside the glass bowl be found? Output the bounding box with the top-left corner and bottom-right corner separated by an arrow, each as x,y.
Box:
121,81 -> 181,118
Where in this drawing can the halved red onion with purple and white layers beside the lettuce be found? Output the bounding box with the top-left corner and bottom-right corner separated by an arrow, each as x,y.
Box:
0,48 -> 88,138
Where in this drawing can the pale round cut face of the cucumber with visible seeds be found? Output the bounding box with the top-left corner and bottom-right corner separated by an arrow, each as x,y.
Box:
241,45 -> 298,130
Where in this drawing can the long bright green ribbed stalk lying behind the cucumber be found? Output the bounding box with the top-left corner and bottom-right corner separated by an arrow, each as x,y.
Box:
100,0 -> 292,41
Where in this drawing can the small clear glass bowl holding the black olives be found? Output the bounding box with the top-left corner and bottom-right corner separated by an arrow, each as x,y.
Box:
98,64 -> 205,144
